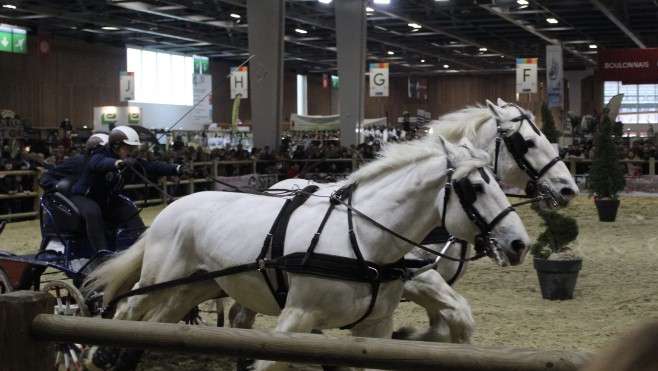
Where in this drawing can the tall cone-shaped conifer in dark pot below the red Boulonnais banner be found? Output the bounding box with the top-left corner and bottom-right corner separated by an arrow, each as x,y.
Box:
588,109 -> 626,222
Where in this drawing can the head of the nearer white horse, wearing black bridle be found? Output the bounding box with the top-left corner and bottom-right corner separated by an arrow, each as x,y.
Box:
441,138 -> 530,266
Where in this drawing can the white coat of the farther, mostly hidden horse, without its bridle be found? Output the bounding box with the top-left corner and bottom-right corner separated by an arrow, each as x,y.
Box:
229,99 -> 578,343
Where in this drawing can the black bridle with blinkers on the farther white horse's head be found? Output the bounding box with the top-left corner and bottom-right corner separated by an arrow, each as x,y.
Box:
494,104 -> 561,199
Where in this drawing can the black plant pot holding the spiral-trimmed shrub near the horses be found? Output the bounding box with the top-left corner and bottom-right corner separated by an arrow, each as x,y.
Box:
533,258 -> 583,300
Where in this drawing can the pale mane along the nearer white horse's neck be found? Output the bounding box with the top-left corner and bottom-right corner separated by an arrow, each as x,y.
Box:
347,134 -> 491,183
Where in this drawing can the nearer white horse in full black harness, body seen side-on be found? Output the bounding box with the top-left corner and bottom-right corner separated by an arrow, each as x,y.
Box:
85,136 -> 530,369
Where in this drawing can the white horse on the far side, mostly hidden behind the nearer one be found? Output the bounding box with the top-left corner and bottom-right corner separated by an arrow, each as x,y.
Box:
229,99 -> 578,343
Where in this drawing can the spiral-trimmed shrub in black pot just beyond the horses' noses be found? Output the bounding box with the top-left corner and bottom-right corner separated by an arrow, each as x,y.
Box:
530,204 -> 583,300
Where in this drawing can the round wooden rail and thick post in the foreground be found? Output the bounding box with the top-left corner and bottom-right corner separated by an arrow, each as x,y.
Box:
0,291 -> 592,371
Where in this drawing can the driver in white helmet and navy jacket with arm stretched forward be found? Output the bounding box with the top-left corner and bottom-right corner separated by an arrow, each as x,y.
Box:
72,126 -> 192,250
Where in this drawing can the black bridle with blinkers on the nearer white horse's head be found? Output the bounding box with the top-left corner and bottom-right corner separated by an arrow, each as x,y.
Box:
441,160 -> 514,264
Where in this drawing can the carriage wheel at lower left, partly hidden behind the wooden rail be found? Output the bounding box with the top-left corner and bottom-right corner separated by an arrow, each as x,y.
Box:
41,281 -> 89,371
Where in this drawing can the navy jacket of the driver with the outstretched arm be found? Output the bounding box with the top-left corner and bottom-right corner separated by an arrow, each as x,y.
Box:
73,145 -> 178,202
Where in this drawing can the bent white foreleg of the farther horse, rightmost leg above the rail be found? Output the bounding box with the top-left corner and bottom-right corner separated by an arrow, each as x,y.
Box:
393,270 -> 475,344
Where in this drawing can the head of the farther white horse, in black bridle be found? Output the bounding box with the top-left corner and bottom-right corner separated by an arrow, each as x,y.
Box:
487,99 -> 579,207
